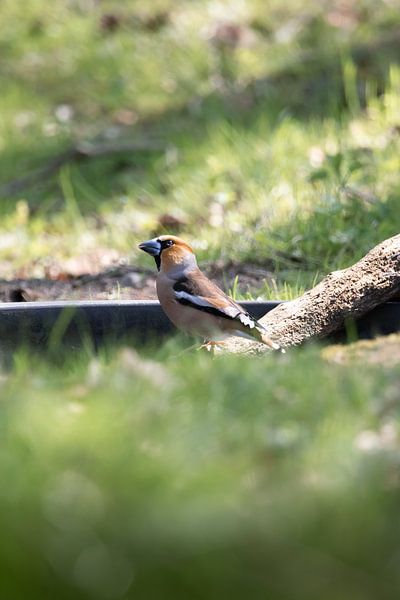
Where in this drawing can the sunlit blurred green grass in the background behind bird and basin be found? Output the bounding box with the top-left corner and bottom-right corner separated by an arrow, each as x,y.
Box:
0,0 -> 400,286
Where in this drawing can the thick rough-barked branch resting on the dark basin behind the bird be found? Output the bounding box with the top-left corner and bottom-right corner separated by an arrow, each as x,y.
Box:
224,235 -> 400,353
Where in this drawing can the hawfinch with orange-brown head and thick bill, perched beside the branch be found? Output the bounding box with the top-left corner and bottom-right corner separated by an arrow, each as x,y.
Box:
139,235 -> 280,350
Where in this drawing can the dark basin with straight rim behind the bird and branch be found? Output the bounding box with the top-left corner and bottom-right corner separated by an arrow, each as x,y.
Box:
0,300 -> 400,351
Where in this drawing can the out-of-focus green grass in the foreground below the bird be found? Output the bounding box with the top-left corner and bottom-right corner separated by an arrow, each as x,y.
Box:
0,343 -> 400,599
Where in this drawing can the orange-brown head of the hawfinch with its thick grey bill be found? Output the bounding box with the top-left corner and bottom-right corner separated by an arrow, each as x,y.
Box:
139,235 -> 196,273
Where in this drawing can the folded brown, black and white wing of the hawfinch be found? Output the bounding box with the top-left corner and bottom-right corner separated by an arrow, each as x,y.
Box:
173,270 -> 258,329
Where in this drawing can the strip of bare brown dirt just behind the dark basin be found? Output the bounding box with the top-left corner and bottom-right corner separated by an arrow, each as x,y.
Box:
0,264 -> 271,302
